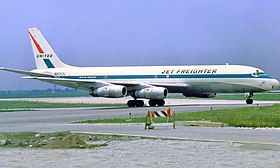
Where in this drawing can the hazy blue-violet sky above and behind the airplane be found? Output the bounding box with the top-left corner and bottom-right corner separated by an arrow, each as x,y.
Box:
0,0 -> 280,90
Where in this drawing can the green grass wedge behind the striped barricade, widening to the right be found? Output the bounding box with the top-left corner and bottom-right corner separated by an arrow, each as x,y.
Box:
80,104 -> 280,127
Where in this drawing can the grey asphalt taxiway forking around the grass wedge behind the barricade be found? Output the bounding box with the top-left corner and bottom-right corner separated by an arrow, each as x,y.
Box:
0,102 -> 280,145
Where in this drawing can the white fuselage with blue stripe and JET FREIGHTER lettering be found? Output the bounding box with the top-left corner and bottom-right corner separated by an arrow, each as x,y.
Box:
33,65 -> 279,93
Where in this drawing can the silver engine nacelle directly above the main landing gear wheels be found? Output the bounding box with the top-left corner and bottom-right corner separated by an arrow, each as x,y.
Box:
133,87 -> 168,100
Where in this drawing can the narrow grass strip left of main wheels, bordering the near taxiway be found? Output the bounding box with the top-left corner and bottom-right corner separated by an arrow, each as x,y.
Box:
0,100 -> 125,109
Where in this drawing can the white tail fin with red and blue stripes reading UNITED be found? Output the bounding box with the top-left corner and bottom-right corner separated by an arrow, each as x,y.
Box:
28,28 -> 71,69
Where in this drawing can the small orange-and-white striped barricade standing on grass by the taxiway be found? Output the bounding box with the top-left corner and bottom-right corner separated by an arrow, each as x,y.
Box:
145,108 -> 175,129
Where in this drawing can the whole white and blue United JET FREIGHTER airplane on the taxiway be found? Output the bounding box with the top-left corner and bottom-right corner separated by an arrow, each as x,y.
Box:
0,28 -> 279,107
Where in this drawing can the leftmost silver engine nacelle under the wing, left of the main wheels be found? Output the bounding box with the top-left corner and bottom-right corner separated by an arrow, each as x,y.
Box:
90,85 -> 127,98
